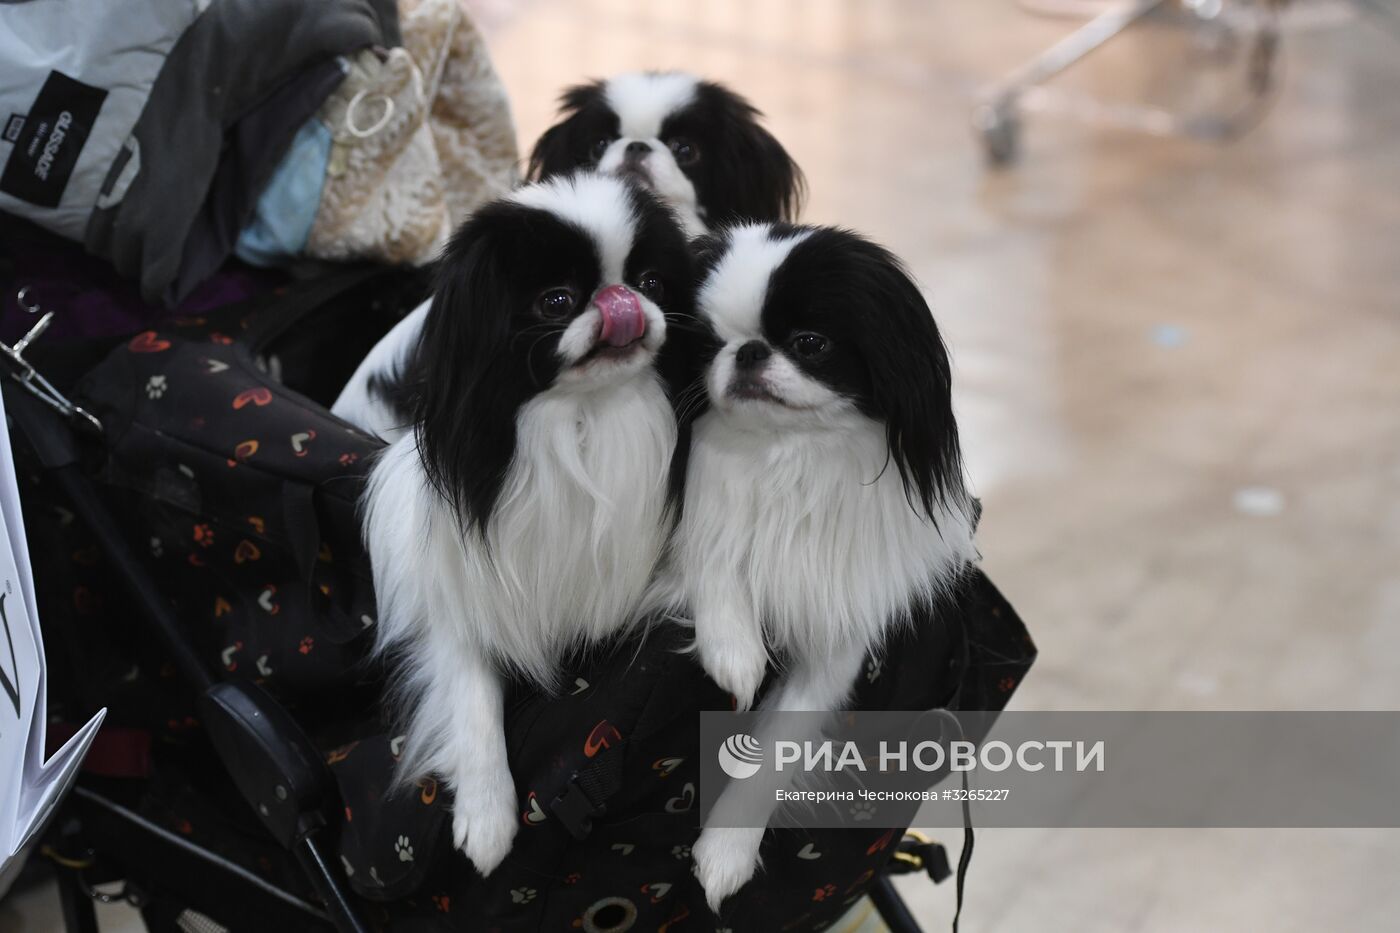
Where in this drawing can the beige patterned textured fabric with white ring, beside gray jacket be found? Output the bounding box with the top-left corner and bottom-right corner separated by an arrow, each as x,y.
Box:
305,0 -> 519,263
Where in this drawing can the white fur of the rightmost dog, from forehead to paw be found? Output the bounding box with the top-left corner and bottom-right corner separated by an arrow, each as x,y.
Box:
665,227 -> 976,909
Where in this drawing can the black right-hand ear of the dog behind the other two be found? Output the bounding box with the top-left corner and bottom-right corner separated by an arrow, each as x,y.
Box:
706,84 -> 806,221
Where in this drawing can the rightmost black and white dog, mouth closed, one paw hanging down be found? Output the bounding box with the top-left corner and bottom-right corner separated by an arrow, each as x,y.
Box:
662,224 -> 976,908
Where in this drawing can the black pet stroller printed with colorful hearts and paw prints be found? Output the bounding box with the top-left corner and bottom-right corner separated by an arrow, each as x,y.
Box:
3,266 -> 1035,933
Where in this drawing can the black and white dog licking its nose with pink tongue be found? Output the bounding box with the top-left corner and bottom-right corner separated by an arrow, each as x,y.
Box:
364,172 -> 694,874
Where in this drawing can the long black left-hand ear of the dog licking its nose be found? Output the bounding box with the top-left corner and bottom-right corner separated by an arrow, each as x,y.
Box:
413,206 -> 529,531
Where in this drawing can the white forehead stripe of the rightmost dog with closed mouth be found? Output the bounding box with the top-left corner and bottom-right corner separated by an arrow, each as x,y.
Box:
699,224 -> 811,343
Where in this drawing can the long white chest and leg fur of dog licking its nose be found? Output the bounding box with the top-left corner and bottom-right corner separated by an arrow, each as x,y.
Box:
364,172 -> 676,874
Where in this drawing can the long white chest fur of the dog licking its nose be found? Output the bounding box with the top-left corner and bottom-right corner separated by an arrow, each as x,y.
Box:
367,371 -> 676,686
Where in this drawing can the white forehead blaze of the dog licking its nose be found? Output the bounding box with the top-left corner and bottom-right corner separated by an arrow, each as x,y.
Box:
508,174 -> 637,284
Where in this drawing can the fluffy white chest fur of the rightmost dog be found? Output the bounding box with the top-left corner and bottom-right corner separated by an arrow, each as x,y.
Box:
672,412 -> 974,661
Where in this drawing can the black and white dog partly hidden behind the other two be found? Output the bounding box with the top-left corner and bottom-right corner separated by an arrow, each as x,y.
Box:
330,71 -> 804,440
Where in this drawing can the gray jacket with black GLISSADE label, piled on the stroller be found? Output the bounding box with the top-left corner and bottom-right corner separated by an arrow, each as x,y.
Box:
0,0 -> 399,304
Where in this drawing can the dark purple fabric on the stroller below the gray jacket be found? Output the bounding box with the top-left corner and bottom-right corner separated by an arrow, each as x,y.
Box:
0,225 -> 287,343
